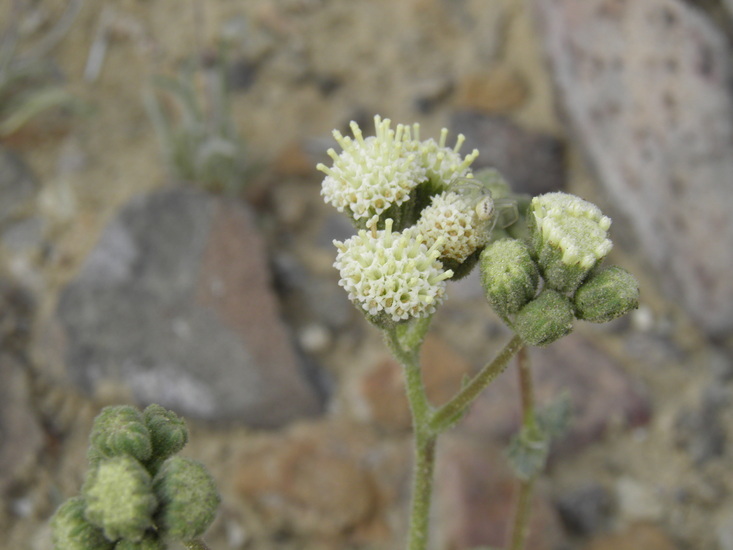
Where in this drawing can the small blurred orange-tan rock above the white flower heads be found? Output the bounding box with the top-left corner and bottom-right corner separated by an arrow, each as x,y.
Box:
456,66 -> 528,113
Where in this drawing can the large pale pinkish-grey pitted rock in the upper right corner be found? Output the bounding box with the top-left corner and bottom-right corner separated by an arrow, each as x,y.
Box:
533,0 -> 733,335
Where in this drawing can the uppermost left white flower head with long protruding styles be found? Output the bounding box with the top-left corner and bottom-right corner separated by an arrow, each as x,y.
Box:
316,115 -> 426,220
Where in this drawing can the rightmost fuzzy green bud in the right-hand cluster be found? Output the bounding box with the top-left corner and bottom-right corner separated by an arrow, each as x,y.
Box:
574,266 -> 639,323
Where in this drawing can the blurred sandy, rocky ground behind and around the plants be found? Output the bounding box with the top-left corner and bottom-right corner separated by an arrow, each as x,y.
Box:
0,0 -> 733,550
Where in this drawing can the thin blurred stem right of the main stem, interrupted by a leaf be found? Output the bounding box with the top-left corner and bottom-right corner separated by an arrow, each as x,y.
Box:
508,348 -> 536,550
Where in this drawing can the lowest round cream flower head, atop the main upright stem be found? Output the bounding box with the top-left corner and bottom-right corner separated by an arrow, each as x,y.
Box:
334,219 -> 453,322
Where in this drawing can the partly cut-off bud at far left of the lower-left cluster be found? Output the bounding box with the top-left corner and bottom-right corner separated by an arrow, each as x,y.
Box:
51,497 -> 114,550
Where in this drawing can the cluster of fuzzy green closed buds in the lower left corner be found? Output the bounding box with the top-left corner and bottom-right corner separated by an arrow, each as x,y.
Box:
51,405 -> 220,550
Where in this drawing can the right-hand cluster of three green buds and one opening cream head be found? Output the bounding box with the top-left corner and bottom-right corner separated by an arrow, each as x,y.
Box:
479,193 -> 639,346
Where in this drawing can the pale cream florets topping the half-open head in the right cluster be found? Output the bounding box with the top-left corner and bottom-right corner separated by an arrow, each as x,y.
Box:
530,192 -> 613,269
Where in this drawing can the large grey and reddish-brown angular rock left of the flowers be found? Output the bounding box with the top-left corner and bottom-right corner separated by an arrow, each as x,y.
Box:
45,188 -> 320,427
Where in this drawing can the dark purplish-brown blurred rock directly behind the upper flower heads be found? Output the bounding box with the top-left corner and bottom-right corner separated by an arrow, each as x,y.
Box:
450,110 -> 565,195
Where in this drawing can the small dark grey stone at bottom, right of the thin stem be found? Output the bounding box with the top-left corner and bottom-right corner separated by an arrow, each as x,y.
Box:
555,482 -> 614,536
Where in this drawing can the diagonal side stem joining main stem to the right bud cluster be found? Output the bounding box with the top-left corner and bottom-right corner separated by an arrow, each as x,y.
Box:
430,335 -> 524,433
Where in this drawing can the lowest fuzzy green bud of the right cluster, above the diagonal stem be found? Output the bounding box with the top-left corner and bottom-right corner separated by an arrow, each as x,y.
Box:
513,289 -> 574,346
